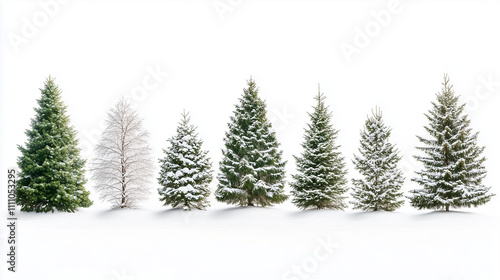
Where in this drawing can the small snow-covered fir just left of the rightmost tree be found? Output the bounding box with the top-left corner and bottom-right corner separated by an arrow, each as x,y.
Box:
351,109 -> 404,211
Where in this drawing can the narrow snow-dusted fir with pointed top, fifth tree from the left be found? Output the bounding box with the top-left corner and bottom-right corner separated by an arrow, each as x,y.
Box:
291,91 -> 347,210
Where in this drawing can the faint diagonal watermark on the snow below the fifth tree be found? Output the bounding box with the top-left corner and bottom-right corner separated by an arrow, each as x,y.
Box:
281,236 -> 340,280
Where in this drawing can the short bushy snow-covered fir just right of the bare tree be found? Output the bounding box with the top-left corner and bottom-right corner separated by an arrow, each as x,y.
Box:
158,112 -> 212,210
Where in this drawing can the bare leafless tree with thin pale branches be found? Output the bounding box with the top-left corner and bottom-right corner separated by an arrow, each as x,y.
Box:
90,97 -> 154,208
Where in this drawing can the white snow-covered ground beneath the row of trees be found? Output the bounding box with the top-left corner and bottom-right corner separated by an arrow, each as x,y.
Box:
0,198 -> 500,280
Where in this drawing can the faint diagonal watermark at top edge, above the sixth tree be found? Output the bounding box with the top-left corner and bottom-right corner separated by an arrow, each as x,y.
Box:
339,0 -> 403,63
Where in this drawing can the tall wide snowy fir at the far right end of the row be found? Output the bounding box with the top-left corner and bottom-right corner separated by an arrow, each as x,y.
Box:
408,75 -> 494,211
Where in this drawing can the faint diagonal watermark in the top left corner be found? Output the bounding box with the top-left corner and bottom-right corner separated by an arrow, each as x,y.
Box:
7,0 -> 69,54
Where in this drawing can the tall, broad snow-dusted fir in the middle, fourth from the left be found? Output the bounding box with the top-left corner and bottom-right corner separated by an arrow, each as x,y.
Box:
215,78 -> 287,206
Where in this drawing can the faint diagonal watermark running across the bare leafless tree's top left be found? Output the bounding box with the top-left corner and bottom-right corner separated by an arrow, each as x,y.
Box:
80,64 -> 170,153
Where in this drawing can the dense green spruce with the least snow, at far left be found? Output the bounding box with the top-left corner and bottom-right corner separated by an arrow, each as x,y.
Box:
16,77 -> 92,212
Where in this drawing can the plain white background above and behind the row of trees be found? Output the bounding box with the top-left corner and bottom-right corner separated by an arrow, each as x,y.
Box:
0,0 -> 500,280
